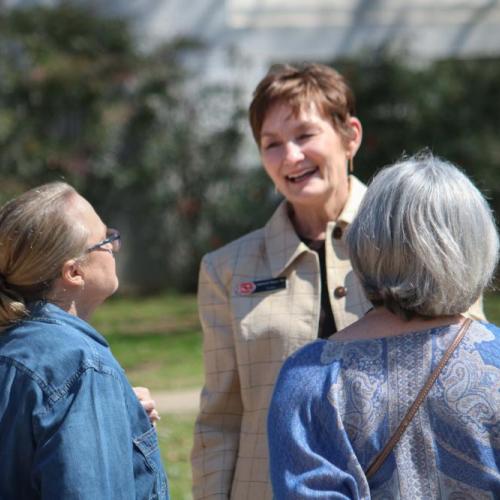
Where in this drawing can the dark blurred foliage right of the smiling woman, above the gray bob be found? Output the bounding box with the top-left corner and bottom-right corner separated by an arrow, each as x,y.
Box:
333,50 -> 500,219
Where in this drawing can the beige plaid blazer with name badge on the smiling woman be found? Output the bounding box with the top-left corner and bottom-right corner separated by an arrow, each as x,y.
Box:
191,176 -> 371,500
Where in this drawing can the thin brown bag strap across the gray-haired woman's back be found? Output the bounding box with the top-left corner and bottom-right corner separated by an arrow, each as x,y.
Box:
365,318 -> 472,479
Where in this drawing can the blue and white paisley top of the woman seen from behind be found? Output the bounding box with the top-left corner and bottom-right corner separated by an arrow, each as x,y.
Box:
268,322 -> 500,500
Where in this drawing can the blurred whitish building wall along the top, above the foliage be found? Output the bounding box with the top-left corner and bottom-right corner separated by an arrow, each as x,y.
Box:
6,0 -> 500,94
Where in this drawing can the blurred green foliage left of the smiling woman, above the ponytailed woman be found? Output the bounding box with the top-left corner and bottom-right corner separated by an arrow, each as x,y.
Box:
0,2 -> 278,292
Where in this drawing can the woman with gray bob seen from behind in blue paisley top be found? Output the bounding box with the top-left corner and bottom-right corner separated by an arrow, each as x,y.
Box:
268,153 -> 500,500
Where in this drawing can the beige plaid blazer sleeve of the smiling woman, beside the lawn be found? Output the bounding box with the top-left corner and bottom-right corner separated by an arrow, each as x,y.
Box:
191,255 -> 243,500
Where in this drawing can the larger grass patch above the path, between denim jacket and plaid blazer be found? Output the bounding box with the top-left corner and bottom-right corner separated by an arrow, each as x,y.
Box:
92,295 -> 203,390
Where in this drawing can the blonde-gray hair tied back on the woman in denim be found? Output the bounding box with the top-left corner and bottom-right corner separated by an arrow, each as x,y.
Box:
0,182 -> 88,330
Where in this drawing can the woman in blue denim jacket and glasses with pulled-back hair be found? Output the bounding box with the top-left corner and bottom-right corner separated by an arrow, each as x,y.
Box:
0,182 -> 169,500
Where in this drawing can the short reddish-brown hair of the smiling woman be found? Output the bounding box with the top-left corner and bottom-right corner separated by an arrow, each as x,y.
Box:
249,64 -> 355,145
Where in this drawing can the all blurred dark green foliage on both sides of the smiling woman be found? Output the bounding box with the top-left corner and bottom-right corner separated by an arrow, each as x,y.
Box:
0,1 -> 500,292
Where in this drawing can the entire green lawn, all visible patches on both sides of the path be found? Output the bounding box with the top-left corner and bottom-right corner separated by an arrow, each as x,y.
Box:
92,294 -> 500,500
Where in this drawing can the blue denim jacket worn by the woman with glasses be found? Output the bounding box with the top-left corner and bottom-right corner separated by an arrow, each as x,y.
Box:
0,303 -> 169,500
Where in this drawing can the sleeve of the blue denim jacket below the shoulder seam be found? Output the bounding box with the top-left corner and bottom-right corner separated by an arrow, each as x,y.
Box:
32,369 -> 154,500
